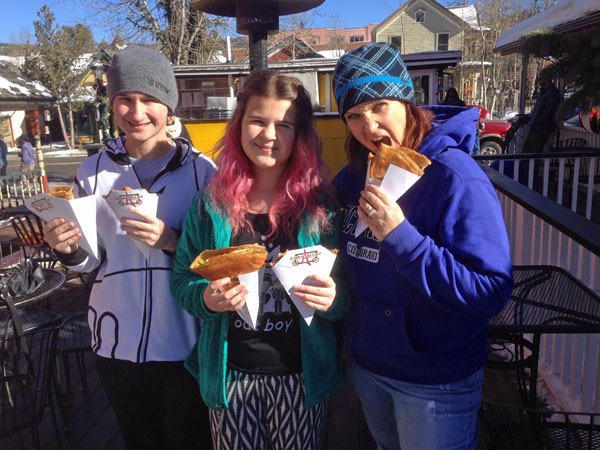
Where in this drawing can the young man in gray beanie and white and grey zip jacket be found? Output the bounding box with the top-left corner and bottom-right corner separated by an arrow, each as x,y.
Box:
44,46 -> 214,450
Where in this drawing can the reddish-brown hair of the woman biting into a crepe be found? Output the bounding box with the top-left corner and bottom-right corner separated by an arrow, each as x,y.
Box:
346,100 -> 433,171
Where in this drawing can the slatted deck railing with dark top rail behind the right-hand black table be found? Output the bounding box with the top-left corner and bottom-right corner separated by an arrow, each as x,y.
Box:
482,167 -> 600,412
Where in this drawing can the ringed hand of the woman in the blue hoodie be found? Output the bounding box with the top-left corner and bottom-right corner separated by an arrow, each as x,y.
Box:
358,184 -> 405,242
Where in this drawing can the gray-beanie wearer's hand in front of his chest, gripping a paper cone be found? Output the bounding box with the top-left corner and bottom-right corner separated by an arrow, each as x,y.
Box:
121,206 -> 179,252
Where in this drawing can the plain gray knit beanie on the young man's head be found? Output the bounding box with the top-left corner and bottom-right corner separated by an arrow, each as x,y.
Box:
106,45 -> 179,111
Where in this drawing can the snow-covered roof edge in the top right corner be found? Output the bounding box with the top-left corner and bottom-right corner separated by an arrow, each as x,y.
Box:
494,0 -> 600,54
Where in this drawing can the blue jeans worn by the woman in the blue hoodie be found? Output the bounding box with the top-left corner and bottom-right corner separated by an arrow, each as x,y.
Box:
348,361 -> 483,450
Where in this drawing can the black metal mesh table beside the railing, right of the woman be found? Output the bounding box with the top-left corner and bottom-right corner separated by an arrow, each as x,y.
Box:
488,266 -> 600,408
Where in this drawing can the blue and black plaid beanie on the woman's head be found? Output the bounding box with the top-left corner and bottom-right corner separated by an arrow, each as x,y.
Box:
333,42 -> 415,121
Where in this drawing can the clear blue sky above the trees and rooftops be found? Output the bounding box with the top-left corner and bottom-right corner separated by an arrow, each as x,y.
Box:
0,0 -> 454,43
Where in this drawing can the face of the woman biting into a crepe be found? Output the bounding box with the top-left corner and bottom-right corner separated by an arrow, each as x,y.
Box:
344,99 -> 406,153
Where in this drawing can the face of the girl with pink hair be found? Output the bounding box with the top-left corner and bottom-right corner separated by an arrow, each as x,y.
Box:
241,96 -> 296,176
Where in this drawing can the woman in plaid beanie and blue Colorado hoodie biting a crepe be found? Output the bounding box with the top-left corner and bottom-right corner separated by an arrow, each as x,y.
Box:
333,43 -> 513,450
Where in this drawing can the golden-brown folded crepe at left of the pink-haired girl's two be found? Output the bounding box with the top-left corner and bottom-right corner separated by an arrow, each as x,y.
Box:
190,244 -> 267,291
